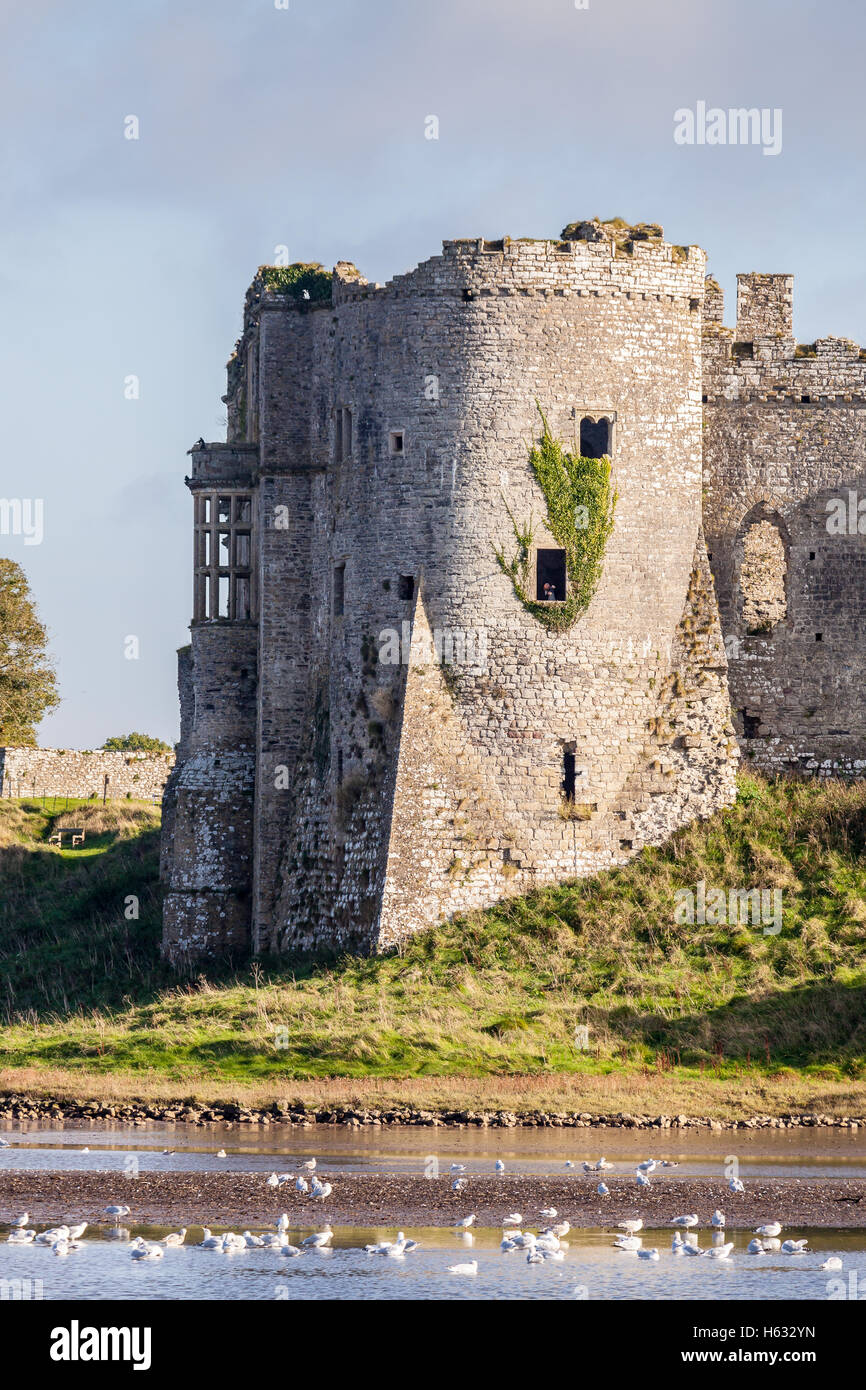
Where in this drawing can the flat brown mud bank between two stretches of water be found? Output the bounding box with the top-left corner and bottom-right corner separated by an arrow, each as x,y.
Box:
0,1168 -> 866,1230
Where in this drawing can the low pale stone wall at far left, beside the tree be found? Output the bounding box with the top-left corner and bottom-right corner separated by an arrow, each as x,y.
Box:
0,748 -> 175,801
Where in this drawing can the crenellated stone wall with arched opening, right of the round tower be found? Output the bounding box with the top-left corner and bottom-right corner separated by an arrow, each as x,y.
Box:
703,275 -> 866,776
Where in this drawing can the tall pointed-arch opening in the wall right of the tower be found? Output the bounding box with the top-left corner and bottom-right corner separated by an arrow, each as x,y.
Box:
733,500 -> 791,637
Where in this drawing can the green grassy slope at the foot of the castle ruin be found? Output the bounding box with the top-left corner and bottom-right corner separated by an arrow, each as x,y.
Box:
0,777 -> 866,1087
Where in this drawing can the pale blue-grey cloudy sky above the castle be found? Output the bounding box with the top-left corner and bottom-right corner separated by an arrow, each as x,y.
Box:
0,0 -> 866,748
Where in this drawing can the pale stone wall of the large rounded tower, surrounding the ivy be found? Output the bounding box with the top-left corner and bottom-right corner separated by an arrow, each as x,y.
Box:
257,240 -> 737,949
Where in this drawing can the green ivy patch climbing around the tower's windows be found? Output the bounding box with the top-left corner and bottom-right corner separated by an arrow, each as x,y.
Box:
493,402 -> 617,632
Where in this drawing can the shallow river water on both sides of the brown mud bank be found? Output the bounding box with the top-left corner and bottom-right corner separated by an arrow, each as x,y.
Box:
0,1122 -> 866,1301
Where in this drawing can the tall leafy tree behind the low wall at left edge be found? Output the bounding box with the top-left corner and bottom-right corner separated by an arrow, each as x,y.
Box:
0,556 -> 60,746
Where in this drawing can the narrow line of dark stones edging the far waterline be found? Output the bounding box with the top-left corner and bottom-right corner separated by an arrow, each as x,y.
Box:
0,1094 -> 866,1130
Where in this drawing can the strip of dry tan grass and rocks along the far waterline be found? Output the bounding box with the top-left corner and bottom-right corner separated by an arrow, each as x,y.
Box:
0,1068 -> 866,1131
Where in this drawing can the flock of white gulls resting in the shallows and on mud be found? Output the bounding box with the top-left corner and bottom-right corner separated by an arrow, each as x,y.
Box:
0,1140 -> 842,1276
